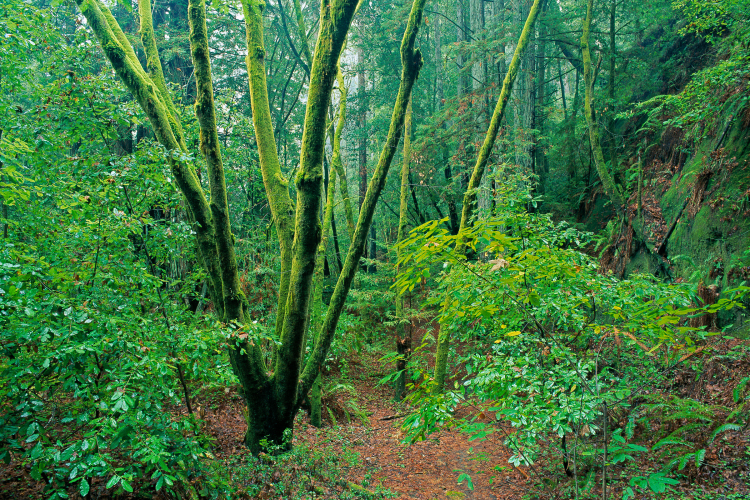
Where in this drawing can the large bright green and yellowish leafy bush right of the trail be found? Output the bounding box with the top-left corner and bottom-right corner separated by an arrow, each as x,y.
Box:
395,171 -> 750,492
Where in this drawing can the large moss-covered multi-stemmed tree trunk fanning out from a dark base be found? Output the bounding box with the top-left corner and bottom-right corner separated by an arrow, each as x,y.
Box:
77,0 -> 425,452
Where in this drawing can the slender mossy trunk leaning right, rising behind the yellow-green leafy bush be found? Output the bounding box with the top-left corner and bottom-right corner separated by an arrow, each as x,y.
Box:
434,0 -> 541,392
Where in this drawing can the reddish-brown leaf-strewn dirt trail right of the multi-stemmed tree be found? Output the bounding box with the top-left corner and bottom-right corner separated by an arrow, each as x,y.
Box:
295,357 -> 527,500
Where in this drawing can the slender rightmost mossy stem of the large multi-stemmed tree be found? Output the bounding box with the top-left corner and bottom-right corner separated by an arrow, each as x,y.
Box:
299,0 -> 426,394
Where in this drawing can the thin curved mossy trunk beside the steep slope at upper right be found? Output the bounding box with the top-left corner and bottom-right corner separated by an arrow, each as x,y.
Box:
581,0 -> 625,213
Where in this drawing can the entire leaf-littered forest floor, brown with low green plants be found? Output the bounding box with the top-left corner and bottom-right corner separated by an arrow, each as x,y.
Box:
0,329 -> 750,500
